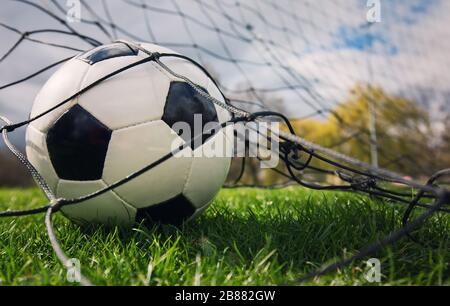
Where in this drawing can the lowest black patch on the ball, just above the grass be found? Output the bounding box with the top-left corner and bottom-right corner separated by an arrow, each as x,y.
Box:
136,194 -> 195,226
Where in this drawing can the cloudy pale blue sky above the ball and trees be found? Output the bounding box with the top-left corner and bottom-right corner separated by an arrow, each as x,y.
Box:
0,0 -> 450,145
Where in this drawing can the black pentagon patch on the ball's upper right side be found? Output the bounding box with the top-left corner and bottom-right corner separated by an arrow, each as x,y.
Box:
162,82 -> 219,149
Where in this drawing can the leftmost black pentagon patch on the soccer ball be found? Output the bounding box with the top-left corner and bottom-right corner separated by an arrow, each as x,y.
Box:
47,105 -> 112,181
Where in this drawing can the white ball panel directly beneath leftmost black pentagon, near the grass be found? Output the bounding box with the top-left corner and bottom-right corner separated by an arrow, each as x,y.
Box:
56,180 -> 136,226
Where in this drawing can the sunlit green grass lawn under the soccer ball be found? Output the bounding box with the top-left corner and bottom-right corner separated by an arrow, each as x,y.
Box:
0,188 -> 450,285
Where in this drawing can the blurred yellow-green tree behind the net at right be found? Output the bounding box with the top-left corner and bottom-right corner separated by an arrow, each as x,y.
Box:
293,85 -> 434,175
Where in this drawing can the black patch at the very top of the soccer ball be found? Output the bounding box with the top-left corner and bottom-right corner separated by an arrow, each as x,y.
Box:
77,43 -> 139,65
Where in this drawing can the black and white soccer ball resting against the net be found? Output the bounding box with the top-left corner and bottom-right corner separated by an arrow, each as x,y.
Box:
26,43 -> 232,226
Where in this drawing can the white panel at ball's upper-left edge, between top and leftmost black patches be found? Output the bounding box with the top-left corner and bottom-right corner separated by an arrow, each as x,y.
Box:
30,59 -> 91,133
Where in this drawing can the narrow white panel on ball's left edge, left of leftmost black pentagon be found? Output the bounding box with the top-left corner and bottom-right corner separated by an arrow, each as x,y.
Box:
26,126 -> 59,191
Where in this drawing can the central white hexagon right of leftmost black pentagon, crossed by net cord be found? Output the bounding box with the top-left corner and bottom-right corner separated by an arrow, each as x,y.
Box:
103,120 -> 191,208
